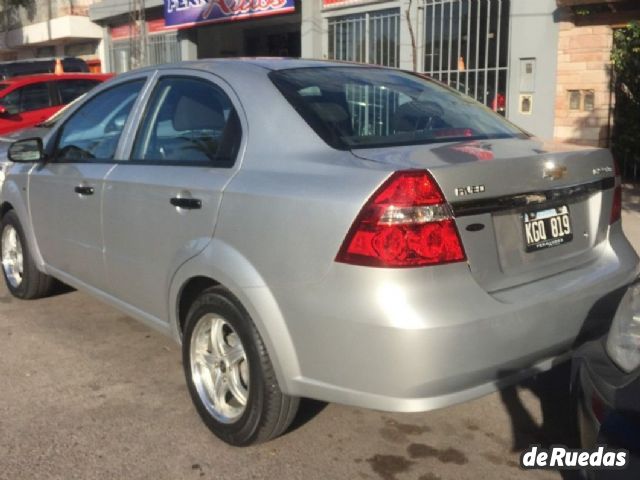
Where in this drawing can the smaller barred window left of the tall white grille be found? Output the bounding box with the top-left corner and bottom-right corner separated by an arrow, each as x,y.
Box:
328,8 -> 400,67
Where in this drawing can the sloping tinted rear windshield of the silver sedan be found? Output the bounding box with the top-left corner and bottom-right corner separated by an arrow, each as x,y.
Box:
269,67 -> 527,149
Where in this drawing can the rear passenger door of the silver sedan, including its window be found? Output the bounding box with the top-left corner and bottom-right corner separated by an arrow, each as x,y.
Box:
103,70 -> 242,321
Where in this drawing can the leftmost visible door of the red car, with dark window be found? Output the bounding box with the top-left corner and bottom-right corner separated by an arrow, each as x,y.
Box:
0,82 -> 60,133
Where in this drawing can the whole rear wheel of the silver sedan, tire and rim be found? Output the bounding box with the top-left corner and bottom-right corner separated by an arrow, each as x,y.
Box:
182,287 -> 299,446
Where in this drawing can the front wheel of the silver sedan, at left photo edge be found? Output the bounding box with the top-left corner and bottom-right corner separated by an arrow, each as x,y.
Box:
0,210 -> 56,300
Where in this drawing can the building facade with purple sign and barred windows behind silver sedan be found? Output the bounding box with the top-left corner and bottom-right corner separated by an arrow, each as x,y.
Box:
63,0 -> 640,146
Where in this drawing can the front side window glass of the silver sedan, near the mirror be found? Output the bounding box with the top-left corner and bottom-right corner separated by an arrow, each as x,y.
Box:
55,80 -> 145,162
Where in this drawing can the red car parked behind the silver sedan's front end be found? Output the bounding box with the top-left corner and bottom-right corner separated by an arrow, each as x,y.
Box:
0,73 -> 113,135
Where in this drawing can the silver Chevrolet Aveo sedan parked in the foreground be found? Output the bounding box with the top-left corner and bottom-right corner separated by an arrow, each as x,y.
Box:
0,59 -> 638,445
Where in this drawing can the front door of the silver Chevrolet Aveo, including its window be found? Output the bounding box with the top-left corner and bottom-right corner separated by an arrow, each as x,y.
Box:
28,78 -> 146,289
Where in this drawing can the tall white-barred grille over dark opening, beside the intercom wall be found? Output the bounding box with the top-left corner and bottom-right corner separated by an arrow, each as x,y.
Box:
424,0 -> 509,113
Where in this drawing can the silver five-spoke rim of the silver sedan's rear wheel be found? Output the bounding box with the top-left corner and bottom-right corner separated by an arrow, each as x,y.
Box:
190,314 -> 249,423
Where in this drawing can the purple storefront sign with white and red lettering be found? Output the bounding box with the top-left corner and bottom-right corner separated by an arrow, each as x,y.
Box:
164,0 -> 295,27
